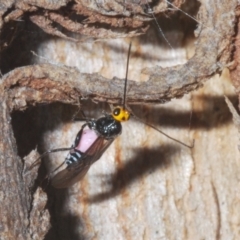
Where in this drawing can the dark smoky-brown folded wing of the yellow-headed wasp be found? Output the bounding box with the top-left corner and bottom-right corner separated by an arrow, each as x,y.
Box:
51,137 -> 115,188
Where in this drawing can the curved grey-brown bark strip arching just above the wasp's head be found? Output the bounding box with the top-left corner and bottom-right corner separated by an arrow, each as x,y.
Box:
0,0 -> 237,109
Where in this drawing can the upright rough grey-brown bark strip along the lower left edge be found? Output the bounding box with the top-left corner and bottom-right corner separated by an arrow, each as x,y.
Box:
0,88 -> 31,240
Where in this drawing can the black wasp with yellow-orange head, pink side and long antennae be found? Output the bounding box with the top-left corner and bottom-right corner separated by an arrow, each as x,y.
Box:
31,43 -> 193,188
